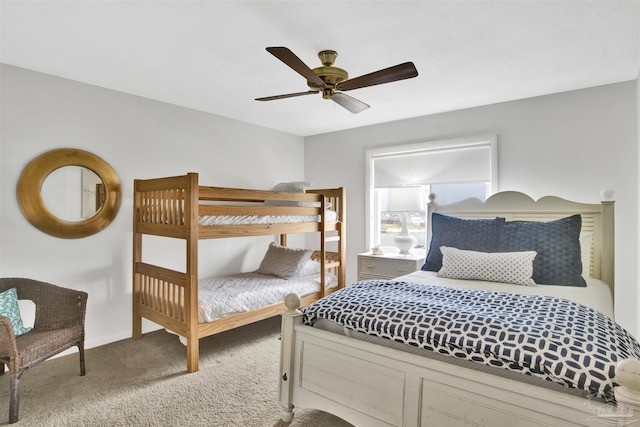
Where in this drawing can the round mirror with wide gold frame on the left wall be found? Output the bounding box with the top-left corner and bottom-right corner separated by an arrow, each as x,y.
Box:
17,148 -> 122,239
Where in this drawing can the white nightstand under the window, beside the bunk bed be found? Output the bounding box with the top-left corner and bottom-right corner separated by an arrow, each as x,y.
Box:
358,252 -> 425,280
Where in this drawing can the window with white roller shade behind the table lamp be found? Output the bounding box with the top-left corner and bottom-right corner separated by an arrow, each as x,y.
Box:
366,135 -> 498,251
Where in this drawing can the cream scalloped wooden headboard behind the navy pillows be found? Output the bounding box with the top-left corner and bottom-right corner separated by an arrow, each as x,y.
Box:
427,191 -> 614,292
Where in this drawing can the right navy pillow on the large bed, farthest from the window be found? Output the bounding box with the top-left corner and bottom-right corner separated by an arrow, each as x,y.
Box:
498,215 -> 587,287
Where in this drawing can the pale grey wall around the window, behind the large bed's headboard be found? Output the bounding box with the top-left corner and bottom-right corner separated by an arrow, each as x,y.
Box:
305,81 -> 638,335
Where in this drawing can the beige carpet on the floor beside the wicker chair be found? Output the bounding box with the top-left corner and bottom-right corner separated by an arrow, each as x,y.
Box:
0,317 -> 351,427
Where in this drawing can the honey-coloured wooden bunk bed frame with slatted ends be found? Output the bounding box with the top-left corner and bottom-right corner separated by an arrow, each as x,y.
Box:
133,173 -> 346,372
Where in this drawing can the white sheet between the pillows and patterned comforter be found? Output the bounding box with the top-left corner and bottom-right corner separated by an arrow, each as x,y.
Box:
393,270 -> 614,319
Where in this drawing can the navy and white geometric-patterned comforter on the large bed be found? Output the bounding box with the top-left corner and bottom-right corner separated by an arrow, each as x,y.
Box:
303,280 -> 640,400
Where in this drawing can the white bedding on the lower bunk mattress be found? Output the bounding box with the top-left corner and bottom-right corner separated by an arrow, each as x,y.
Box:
198,273 -> 338,323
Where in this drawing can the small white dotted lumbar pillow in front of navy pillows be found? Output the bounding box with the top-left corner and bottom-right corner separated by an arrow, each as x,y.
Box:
438,246 -> 536,286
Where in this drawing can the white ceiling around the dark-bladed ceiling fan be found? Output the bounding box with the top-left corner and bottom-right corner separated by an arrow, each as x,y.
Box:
0,0 -> 640,136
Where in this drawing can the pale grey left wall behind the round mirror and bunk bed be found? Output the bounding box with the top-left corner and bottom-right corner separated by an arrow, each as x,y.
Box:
0,65 -> 304,347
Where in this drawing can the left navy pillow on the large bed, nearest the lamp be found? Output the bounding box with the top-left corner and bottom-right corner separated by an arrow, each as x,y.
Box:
422,216 -> 504,271
